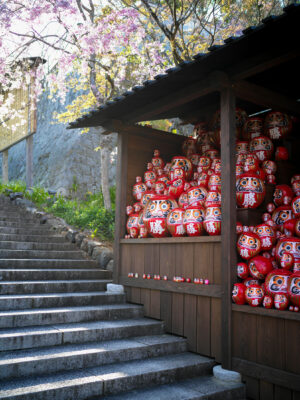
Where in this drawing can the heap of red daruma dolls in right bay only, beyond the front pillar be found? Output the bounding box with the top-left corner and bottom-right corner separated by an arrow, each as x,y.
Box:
232,112 -> 300,312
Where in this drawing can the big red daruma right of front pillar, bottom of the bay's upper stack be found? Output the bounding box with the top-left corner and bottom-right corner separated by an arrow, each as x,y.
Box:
236,172 -> 266,208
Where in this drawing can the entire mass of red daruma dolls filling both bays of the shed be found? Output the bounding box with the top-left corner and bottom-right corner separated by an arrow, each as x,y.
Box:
125,108 -> 300,311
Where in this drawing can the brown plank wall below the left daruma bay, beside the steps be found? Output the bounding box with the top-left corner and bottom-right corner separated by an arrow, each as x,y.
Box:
121,238 -> 221,361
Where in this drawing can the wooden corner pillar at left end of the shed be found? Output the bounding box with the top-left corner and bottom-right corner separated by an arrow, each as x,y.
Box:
113,133 -> 128,283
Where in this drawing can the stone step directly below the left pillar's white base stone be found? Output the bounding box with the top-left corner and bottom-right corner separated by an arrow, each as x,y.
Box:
0,291 -> 125,310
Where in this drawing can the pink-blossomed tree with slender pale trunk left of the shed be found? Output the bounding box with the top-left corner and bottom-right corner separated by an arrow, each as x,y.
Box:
0,0 -> 166,208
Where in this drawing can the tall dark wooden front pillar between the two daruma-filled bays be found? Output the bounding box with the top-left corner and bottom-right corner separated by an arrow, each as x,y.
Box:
221,86 -> 236,369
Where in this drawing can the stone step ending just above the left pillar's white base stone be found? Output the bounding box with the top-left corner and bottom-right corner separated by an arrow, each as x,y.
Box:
0,268 -> 111,281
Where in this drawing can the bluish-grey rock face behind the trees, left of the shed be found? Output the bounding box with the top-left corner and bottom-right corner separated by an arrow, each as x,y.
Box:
0,93 -> 116,194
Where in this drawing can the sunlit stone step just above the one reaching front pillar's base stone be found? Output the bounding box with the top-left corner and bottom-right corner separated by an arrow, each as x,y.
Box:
0,335 -> 187,380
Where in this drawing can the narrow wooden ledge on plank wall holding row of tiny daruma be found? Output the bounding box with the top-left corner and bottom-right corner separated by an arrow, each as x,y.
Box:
120,276 -> 222,298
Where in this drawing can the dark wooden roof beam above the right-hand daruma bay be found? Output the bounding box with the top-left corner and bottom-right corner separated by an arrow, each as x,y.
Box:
233,81 -> 300,115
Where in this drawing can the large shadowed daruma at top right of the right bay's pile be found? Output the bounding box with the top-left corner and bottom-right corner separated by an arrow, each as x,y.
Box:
265,111 -> 292,140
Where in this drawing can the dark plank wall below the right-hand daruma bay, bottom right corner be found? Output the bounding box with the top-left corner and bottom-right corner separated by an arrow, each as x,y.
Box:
232,306 -> 300,400
